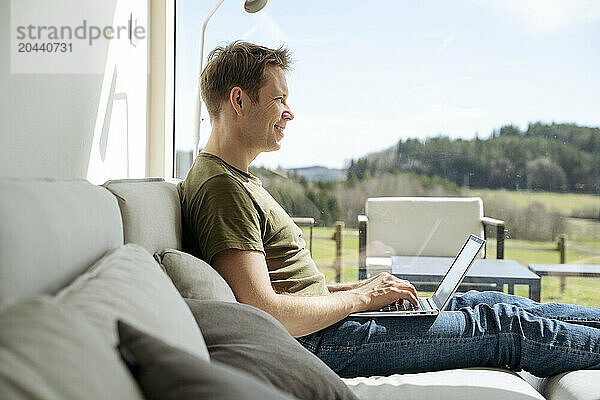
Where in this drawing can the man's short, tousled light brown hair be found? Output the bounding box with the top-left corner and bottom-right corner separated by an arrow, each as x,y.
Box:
200,41 -> 291,120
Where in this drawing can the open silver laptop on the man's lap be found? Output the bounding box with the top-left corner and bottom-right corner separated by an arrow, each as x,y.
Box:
350,235 -> 485,318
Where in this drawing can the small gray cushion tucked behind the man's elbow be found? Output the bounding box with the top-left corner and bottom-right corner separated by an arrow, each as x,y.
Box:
154,249 -> 236,302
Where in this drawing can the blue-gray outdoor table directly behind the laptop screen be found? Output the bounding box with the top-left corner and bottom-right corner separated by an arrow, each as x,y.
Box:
367,256 -> 541,301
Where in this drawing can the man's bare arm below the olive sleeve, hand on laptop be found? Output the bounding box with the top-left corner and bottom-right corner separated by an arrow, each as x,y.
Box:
212,249 -> 417,337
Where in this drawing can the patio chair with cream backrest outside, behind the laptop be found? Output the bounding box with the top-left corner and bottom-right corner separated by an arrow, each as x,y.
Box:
358,197 -> 505,284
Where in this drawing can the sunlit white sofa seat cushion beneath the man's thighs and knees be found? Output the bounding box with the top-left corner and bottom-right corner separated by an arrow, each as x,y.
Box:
343,368 -> 544,400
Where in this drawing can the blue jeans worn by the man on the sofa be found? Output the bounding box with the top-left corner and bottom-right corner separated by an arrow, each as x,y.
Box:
298,291 -> 600,378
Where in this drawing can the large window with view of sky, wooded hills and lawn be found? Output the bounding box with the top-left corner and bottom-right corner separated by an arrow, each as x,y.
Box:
175,0 -> 600,305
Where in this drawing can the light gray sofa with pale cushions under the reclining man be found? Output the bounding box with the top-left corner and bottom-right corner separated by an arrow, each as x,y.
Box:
0,178 -> 600,400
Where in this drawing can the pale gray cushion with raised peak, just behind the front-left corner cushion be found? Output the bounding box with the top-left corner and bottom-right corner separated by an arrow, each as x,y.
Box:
56,244 -> 208,359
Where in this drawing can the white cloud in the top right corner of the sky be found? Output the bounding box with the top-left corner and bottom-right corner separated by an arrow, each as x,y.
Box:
492,0 -> 600,33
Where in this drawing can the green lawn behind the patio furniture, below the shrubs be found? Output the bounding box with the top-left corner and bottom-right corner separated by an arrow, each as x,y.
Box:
303,227 -> 600,306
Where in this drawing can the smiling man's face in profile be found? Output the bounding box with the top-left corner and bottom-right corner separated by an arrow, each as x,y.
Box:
244,65 -> 294,152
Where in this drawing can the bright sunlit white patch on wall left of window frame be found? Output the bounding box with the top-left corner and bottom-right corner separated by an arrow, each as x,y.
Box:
87,1 -> 148,184
